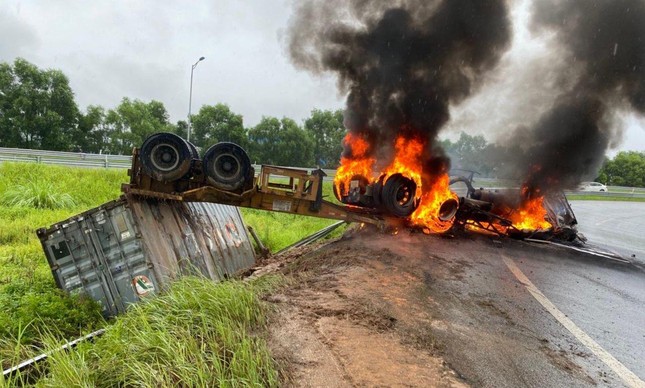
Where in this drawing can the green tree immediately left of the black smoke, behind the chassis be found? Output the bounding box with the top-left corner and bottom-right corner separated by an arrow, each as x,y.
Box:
305,109 -> 347,168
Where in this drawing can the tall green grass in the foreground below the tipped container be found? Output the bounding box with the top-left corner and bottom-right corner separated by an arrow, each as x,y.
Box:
6,277 -> 281,387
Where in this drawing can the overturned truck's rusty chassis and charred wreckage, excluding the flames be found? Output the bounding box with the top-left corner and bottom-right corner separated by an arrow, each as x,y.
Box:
122,133 -> 585,244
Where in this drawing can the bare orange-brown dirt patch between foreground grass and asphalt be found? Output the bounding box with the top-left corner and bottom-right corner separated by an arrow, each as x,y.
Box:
259,229 -> 465,387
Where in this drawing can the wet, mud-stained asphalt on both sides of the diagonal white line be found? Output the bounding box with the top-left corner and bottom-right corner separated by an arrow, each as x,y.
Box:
424,238 -> 645,387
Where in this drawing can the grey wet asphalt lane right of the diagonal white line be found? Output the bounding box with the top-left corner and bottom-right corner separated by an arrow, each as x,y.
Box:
503,242 -> 645,386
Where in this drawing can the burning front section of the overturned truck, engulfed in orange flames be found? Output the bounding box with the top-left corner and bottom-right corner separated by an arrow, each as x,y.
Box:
334,133 -> 584,242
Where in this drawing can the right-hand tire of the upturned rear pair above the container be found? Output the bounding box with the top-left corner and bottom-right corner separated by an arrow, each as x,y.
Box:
203,143 -> 253,191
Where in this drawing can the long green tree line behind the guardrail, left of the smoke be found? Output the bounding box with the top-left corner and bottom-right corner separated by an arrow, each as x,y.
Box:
0,58 -> 345,168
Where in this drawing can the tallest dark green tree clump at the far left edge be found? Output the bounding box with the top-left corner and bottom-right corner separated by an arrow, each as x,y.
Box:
0,58 -> 79,151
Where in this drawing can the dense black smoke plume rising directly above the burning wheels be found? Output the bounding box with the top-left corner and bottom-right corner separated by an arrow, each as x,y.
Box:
289,0 -> 511,176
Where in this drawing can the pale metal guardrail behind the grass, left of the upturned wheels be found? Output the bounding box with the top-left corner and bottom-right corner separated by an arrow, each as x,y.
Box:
0,147 -> 132,168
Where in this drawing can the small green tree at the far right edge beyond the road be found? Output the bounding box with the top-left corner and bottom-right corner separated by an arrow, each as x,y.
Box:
598,151 -> 645,187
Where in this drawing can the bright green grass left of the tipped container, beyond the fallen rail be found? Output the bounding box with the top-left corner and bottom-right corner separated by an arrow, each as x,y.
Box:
0,163 -> 127,367
